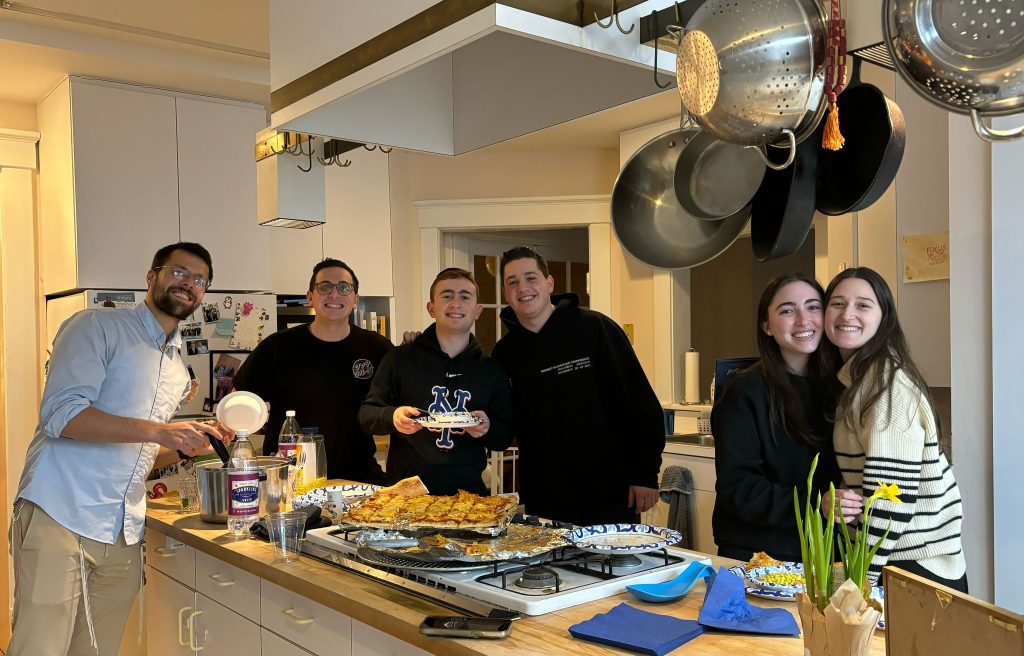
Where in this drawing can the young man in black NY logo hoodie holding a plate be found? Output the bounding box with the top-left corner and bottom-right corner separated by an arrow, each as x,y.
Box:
359,268 -> 520,494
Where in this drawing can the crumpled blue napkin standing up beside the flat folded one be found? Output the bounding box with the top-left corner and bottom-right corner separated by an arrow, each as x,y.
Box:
697,567 -> 800,636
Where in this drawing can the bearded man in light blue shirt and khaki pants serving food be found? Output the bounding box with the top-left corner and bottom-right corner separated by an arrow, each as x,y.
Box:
7,242 -> 224,655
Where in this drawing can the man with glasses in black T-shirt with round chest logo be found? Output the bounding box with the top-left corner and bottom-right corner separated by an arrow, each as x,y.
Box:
233,258 -> 392,483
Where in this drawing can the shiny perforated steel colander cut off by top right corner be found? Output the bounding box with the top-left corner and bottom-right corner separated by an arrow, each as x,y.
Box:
882,0 -> 1024,142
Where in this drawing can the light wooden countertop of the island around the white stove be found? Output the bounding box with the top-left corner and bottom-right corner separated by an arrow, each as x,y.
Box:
146,499 -> 886,656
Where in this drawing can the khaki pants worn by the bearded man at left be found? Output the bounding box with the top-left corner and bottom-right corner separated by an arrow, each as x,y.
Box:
7,499 -> 142,656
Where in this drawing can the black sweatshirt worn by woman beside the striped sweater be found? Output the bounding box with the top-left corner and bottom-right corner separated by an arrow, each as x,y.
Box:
711,365 -> 841,561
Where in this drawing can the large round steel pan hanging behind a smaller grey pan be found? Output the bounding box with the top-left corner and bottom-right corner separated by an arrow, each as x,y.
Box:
611,128 -> 750,269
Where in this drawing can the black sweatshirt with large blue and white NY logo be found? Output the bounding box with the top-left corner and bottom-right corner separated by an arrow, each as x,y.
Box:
359,323 -> 512,494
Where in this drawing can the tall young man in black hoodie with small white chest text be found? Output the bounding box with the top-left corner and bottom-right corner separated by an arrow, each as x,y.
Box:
492,247 -> 665,526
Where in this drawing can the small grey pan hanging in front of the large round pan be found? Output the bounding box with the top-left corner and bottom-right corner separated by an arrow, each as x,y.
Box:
675,130 -> 765,221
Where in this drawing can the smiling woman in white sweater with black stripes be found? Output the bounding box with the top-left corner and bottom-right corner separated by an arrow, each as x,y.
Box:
824,267 -> 967,592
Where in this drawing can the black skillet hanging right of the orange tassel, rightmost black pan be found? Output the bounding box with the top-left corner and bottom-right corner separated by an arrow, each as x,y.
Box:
816,56 -> 906,216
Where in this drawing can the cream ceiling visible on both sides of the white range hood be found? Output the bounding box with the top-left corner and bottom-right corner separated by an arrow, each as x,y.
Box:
0,0 -> 679,152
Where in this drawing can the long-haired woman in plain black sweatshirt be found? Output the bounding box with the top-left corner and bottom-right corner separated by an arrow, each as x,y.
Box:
711,273 -> 839,561
